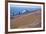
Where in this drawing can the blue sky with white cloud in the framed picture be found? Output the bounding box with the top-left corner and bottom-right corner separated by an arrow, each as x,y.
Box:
10,4 -> 41,15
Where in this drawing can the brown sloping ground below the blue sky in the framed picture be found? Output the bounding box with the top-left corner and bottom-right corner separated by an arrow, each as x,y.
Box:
10,10 -> 41,28
